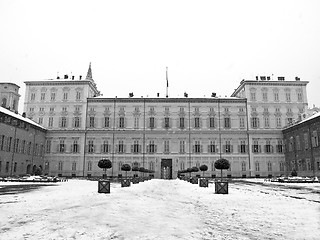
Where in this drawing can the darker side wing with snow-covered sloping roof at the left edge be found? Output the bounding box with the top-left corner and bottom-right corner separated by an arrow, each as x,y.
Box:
0,107 -> 49,177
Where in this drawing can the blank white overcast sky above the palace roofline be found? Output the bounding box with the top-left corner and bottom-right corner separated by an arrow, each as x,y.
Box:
0,0 -> 320,112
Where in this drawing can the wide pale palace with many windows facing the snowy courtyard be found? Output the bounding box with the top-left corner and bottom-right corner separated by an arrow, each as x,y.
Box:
24,65 -> 308,178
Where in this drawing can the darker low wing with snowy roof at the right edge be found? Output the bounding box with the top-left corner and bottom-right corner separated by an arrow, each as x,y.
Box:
283,113 -> 320,177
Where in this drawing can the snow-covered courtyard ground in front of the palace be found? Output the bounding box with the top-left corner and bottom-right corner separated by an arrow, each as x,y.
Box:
0,179 -> 320,240
